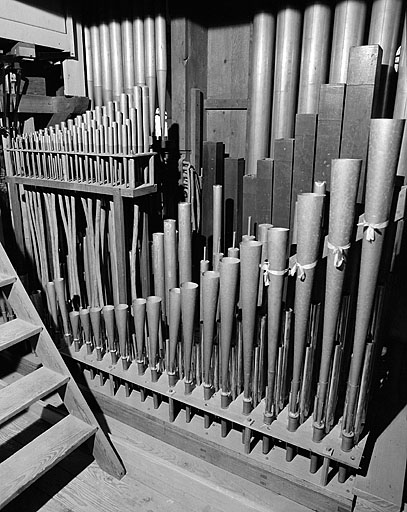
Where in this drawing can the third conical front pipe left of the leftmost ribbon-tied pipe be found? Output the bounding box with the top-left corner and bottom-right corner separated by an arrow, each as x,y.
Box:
202,270 -> 219,400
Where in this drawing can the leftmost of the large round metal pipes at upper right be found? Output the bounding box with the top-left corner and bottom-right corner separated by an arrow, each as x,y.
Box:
245,4 -> 276,174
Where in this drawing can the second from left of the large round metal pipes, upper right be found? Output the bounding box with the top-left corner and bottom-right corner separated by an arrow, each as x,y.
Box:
270,1 -> 302,158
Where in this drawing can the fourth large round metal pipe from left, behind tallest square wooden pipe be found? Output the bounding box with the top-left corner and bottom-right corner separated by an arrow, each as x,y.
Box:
329,0 -> 367,84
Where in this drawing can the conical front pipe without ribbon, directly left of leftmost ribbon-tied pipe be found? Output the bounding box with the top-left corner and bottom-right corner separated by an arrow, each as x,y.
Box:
240,240 -> 262,415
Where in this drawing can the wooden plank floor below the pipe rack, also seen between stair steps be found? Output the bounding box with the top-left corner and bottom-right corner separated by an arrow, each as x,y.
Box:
0,378 -> 310,512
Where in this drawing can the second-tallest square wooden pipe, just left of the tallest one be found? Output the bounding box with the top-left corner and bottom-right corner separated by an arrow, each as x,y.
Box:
314,84 -> 345,190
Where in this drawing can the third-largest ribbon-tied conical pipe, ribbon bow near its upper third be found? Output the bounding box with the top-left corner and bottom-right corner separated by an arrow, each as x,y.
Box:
287,193 -> 325,432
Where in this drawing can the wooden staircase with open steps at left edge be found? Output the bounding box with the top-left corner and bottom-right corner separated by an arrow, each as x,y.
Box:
0,244 -> 125,509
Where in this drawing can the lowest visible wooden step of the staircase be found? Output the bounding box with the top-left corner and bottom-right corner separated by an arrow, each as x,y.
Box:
0,415 -> 96,509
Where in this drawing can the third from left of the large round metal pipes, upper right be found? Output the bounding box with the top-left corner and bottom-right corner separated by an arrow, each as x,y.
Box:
297,0 -> 332,114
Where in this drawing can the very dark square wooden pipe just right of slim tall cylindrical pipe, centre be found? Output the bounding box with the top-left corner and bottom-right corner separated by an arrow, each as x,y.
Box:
223,158 -> 244,250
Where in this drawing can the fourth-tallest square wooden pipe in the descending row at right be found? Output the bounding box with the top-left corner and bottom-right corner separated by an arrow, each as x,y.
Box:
271,139 -> 294,228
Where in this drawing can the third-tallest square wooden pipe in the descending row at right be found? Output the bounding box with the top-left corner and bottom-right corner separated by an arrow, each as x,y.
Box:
290,114 -> 317,230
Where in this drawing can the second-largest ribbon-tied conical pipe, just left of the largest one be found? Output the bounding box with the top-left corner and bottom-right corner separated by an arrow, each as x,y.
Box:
313,159 -> 362,442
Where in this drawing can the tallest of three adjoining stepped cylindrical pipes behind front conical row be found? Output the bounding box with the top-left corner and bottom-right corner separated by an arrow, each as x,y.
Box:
178,203 -> 192,284
